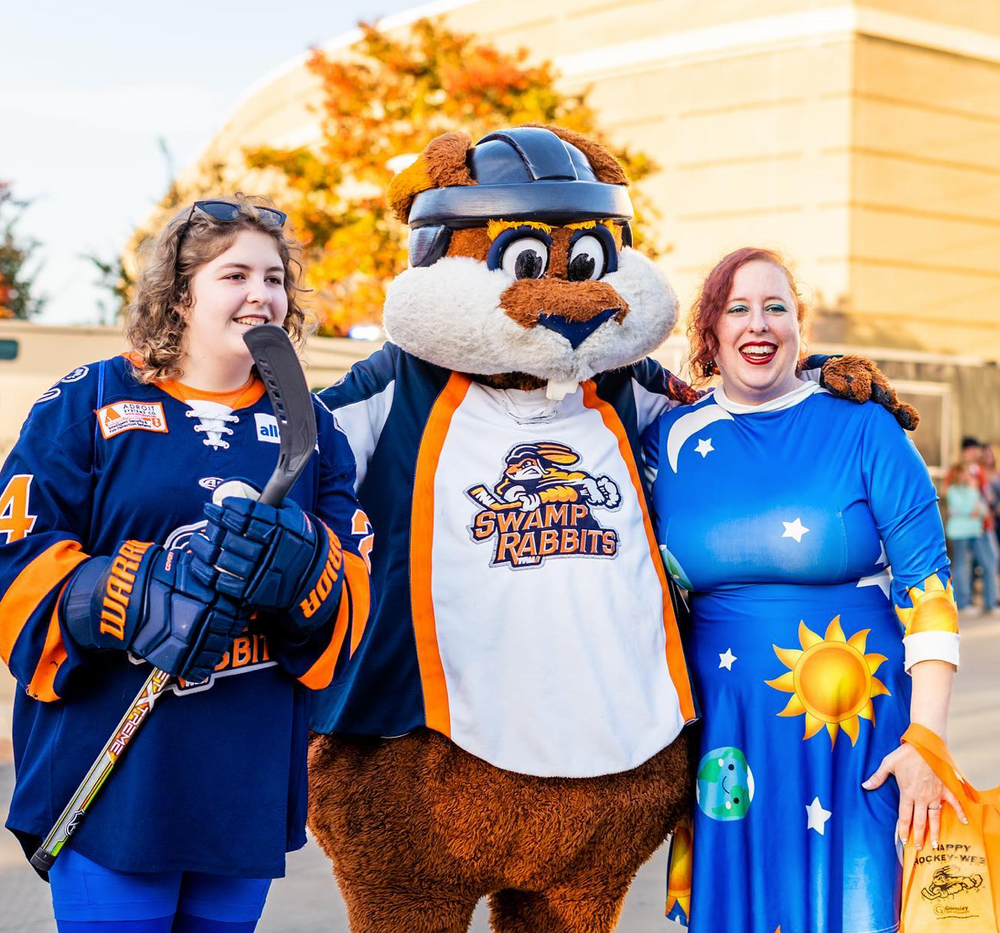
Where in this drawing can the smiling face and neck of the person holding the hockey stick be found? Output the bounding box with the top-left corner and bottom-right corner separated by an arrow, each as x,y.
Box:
180,230 -> 288,389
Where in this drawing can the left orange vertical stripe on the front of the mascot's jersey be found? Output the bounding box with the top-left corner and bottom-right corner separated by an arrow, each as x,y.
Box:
410,373 -> 472,736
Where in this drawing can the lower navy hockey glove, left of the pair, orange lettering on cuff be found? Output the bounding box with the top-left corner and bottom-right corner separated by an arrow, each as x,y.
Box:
60,541 -> 247,683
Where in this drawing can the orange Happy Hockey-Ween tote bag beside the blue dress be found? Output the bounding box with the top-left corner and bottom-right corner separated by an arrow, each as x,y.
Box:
899,723 -> 1000,933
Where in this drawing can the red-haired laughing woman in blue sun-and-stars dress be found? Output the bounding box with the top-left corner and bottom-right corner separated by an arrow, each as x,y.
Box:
645,249 -> 961,933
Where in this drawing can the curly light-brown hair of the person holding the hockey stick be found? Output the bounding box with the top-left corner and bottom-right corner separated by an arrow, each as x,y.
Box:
125,191 -> 312,383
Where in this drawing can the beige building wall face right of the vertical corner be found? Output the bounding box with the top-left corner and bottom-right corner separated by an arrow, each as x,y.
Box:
848,27 -> 1000,358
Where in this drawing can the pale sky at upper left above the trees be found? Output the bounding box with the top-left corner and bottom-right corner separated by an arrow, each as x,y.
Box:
0,0 -> 426,324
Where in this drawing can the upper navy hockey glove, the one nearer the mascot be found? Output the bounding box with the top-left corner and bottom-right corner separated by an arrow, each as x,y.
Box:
191,496 -> 343,639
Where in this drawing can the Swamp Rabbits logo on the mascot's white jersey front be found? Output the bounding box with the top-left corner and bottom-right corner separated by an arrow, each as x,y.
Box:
465,441 -> 621,569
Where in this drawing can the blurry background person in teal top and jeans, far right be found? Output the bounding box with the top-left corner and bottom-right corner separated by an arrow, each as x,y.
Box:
945,458 -> 997,613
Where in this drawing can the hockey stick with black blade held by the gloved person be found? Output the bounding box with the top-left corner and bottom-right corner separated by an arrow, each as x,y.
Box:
31,324 -> 316,872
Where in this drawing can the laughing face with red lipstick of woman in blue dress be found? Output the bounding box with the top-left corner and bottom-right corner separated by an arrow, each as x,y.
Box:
715,260 -> 801,405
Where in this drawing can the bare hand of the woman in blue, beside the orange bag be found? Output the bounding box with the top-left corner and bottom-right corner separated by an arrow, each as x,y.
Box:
861,743 -> 969,849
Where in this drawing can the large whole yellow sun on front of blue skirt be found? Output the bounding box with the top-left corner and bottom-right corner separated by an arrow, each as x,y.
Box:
765,616 -> 889,748
